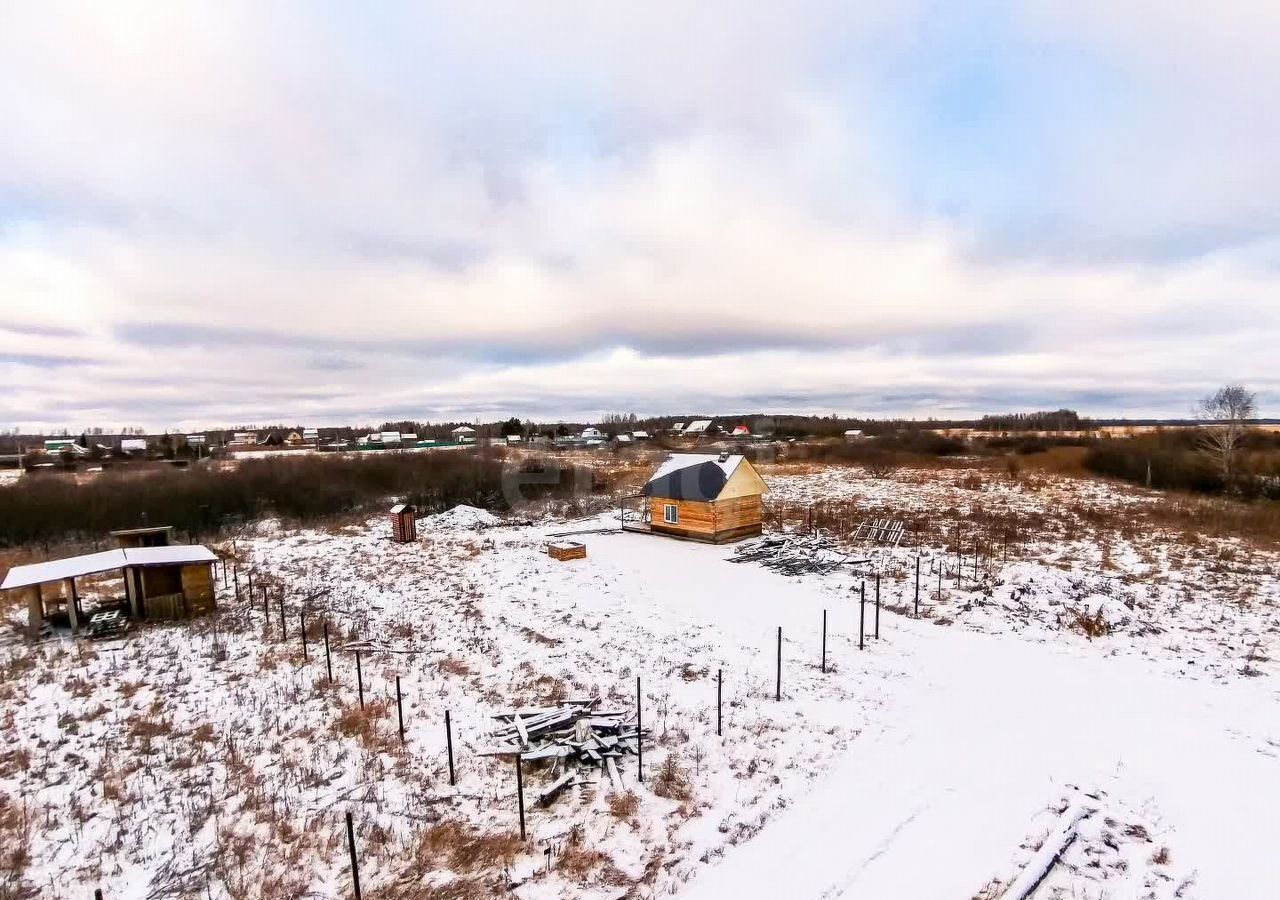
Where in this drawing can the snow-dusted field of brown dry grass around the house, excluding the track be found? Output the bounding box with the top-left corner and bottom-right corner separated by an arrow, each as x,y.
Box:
0,465 -> 1280,900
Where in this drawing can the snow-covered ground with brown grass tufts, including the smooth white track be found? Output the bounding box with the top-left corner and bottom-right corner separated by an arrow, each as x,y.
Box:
0,467 -> 1280,900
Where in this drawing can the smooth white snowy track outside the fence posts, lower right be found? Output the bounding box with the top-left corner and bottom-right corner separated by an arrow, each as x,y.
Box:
681,623 -> 1280,900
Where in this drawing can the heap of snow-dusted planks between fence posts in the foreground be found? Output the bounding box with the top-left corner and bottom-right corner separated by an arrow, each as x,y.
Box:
481,699 -> 649,807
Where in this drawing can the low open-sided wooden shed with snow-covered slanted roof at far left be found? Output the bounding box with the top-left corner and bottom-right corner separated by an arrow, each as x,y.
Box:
0,545 -> 218,634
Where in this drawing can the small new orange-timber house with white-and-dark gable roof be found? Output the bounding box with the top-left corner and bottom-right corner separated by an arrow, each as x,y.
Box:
643,453 -> 768,544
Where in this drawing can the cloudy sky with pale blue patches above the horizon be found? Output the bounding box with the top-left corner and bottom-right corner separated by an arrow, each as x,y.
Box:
0,0 -> 1280,428
